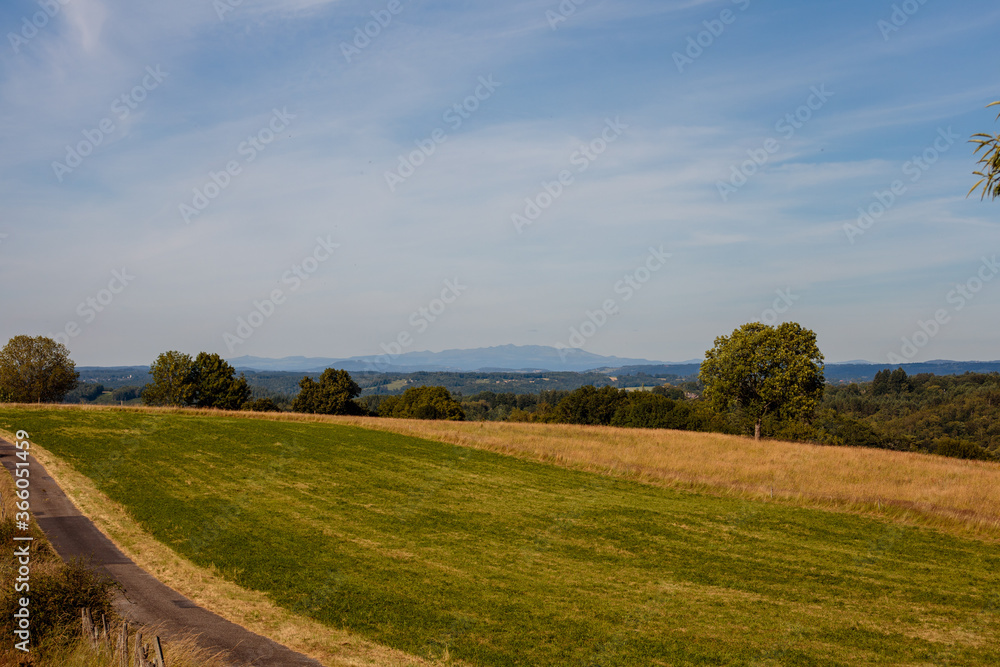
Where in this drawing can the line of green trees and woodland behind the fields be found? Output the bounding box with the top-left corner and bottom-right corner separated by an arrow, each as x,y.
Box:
0,330 -> 1000,460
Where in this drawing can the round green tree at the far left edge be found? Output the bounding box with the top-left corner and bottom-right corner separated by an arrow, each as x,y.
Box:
0,336 -> 80,403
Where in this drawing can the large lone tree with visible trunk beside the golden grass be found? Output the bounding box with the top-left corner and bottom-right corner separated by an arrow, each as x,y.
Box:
699,322 -> 824,439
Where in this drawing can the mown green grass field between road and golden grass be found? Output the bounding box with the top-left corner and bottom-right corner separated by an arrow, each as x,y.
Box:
0,409 -> 1000,666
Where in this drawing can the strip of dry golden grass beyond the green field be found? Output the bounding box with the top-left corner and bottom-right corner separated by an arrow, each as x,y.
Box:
336,417 -> 1000,539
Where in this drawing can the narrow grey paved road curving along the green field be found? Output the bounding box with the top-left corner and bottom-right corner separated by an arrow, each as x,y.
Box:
0,438 -> 322,667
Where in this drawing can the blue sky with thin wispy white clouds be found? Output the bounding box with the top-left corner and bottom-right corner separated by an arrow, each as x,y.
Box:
0,0 -> 1000,366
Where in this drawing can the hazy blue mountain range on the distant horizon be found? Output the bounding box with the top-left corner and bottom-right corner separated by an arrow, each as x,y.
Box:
228,345 -> 700,373
